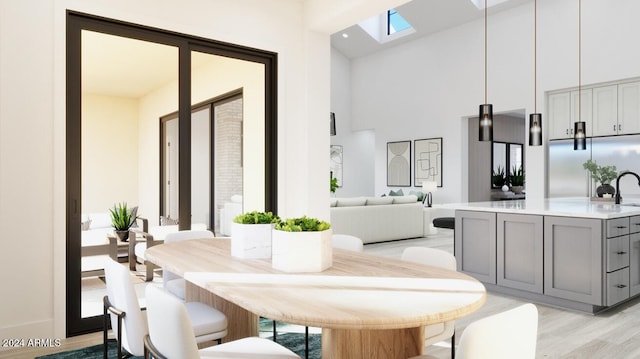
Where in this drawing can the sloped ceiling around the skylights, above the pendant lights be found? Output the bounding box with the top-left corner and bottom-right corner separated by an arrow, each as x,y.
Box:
331,0 -> 533,59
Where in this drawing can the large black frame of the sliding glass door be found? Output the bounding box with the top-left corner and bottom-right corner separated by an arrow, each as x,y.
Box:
66,11 -> 278,336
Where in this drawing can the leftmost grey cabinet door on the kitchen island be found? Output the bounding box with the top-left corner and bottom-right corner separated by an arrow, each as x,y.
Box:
454,211 -> 496,284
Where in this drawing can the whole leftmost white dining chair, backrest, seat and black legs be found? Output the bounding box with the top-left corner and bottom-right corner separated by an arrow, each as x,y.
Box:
103,259 -> 228,358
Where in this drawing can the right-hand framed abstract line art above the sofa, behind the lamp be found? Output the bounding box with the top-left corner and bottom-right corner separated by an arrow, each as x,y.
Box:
413,137 -> 442,187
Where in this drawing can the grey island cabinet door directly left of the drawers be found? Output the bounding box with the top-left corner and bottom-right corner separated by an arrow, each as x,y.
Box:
544,216 -> 604,305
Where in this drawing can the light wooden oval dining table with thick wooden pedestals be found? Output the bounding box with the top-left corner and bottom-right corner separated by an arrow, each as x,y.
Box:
145,238 -> 486,359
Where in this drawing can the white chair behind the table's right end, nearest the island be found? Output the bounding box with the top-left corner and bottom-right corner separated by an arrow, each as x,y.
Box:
401,247 -> 456,359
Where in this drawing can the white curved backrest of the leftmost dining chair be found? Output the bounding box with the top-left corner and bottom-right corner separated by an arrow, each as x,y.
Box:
104,259 -> 148,356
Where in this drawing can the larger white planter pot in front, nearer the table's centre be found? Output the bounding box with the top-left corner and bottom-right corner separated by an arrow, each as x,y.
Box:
271,229 -> 333,273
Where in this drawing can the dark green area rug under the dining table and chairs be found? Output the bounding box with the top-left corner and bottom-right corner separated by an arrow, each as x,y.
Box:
36,333 -> 322,359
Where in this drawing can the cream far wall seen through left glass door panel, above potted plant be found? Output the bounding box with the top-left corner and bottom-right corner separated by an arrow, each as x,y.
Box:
82,93 -> 138,213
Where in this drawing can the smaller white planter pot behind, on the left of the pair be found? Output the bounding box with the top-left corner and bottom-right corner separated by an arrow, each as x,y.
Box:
231,222 -> 273,259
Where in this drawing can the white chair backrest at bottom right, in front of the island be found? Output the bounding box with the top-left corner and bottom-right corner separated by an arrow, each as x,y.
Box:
456,303 -> 538,359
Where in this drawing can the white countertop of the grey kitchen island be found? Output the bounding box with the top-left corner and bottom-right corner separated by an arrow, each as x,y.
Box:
434,197 -> 640,219
